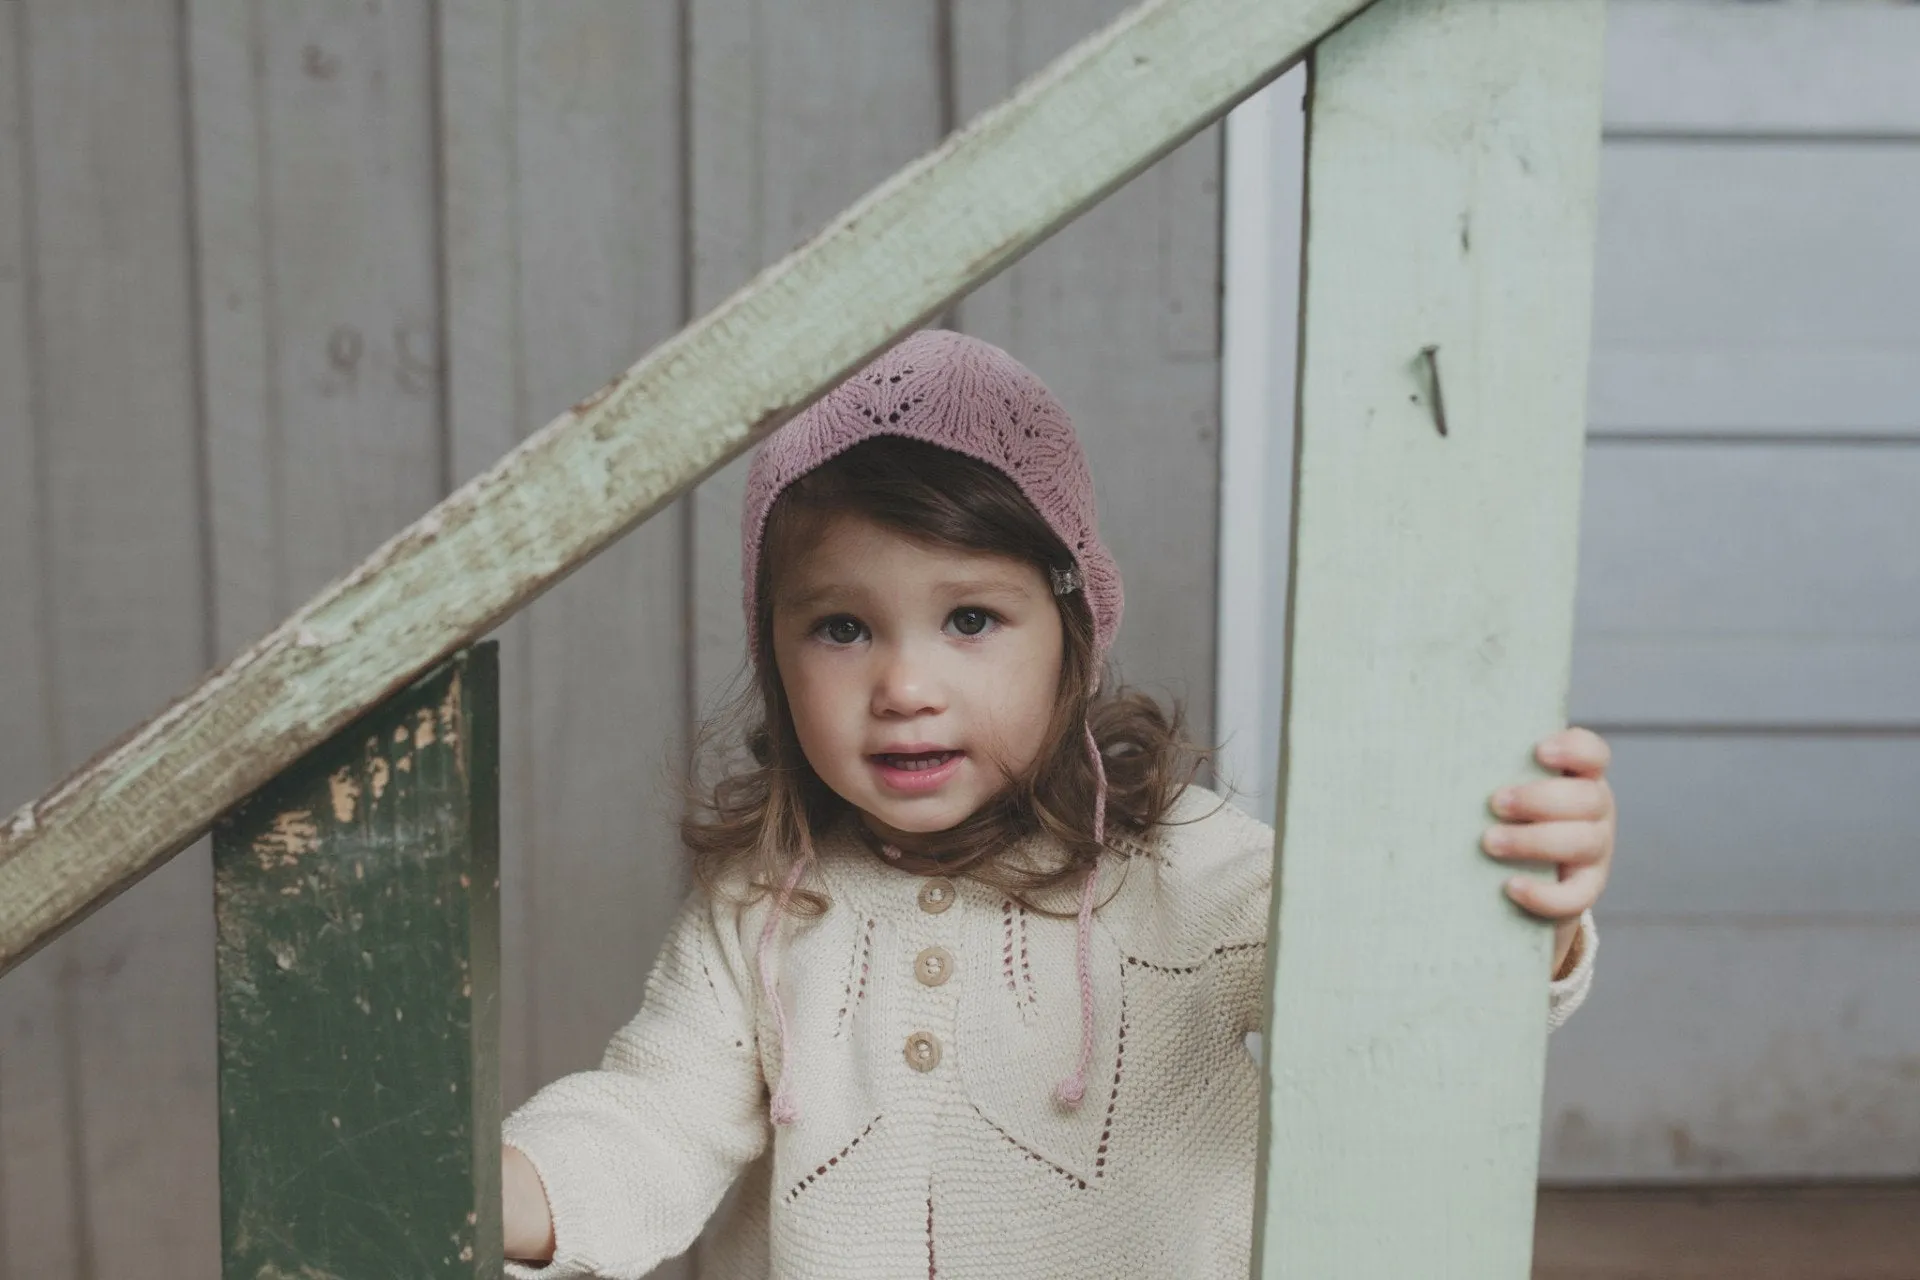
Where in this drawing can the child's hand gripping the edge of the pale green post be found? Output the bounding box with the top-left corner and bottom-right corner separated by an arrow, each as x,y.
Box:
1480,729 -> 1615,977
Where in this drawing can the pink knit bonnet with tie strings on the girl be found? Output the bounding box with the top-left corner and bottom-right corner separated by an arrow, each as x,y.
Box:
741,330 -> 1123,1125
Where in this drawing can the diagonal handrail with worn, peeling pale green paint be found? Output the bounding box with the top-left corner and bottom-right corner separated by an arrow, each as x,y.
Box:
0,0 -> 1367,973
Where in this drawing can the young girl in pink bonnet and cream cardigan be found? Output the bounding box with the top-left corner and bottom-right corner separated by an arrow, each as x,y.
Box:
503,332 -> 1613,1280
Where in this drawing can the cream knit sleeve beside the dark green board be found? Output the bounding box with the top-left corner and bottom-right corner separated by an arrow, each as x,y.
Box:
503,896 -> 768,1280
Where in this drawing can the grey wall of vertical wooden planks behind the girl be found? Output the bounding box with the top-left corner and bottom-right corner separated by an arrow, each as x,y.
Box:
0,0 -> 1219,1280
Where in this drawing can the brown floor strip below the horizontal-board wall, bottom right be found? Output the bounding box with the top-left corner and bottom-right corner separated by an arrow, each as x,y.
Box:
1534,1182 -> 1920,1280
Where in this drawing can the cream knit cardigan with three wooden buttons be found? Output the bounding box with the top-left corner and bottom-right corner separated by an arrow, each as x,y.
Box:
505,787 -> 1596,1280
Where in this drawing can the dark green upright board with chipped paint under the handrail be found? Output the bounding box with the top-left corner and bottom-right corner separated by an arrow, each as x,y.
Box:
213,645 -> 501,1280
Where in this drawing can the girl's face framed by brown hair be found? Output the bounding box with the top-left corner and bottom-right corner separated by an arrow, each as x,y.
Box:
772,514 -> 1064,848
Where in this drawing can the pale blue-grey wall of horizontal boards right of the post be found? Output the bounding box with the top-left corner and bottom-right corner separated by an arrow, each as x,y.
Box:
1544,0 -> 1920,1180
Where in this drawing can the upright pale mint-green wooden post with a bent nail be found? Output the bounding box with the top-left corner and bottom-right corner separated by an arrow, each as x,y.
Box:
1258,0 -> 1603,1280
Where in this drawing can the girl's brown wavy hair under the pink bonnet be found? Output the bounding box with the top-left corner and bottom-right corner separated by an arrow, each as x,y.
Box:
680,436 -> 1210,913
